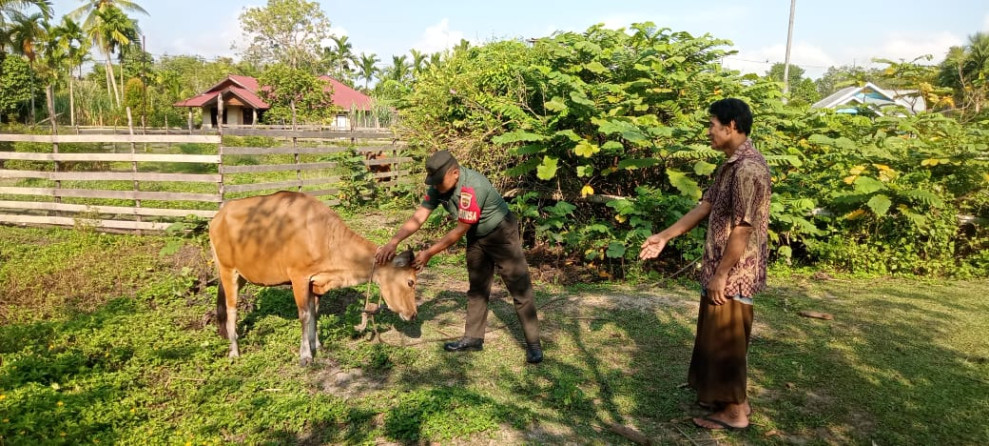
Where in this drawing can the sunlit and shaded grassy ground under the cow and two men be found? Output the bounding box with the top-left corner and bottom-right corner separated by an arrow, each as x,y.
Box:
0,211 -> 989,445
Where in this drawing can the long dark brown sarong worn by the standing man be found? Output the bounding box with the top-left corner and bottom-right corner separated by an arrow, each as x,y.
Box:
687,294 -> 753,405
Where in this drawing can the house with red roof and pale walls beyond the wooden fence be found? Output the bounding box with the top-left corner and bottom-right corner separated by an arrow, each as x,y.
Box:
173,74 -> 372,130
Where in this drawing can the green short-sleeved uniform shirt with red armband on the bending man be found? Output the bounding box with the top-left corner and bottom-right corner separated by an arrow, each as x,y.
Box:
422,167 -> 509,237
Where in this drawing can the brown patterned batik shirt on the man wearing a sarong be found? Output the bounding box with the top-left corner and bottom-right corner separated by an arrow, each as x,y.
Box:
701,139 -> 772,297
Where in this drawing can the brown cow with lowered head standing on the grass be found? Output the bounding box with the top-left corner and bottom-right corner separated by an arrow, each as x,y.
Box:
209,192 -> 417,366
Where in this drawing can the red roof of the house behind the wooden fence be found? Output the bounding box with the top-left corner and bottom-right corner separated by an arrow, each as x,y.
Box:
173,74 -> 371,110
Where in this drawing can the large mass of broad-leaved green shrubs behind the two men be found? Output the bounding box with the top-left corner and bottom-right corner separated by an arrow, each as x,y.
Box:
401,23 -> 989,275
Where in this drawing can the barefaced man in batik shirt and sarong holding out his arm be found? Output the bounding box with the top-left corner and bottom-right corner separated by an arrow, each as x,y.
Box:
639,98 -> 771,429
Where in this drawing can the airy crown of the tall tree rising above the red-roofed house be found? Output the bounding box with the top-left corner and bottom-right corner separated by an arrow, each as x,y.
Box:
240,0 -> 331,69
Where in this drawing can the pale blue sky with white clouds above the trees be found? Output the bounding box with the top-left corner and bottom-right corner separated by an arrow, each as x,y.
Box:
54,0 -> 989,78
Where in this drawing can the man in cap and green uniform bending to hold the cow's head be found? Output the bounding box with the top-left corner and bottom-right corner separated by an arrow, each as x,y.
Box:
375,150 -> 543,364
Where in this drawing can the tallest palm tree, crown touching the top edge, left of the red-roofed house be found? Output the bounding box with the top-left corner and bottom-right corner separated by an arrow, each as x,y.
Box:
67,0 -> 148,107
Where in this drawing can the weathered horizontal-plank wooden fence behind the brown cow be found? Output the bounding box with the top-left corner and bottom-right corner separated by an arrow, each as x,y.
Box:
0,131 -> 411,231
